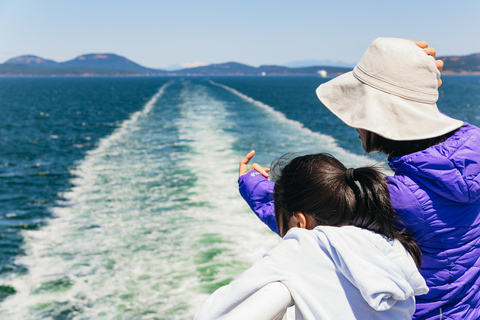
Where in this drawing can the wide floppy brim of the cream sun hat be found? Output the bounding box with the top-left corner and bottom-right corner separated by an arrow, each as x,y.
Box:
316,72 -> 463,141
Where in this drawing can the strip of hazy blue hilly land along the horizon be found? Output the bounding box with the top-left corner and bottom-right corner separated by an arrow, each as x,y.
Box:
0,53 -> 480,77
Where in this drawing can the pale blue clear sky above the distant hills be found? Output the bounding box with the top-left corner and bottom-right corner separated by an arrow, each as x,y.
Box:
0,0 -> 480,68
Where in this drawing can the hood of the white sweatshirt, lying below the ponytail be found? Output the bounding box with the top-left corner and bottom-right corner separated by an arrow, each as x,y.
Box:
315,226 -> 428,311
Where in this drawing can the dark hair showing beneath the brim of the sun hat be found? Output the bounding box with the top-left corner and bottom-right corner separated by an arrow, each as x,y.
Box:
365,129 -> 459,159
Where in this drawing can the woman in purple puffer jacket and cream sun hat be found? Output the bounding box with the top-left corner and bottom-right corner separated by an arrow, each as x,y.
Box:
239,38 -> 480,319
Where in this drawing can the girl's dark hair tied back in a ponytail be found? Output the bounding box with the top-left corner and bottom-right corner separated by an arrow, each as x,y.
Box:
271,153 -> 422,267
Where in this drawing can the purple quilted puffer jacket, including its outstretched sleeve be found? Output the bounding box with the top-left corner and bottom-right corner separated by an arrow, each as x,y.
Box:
238,124 -> 480,320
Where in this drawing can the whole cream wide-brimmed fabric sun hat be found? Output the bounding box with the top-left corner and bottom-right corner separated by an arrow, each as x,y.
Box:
317,38 -> 463,141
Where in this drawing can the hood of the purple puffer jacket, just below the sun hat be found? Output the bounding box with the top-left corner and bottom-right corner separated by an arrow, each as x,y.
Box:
389,124 -> 480,203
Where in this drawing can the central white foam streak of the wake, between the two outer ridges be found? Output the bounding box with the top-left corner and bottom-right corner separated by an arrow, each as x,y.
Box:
169,82 -> 279,316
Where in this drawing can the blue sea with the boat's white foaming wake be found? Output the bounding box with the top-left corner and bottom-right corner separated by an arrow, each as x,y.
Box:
0,76 -> 480,320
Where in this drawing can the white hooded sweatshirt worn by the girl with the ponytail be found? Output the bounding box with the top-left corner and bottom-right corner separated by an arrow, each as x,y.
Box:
194,226 -> 428,320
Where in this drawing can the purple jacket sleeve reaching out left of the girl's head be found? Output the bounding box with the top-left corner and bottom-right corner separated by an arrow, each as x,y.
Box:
238,170 -> 278,234
